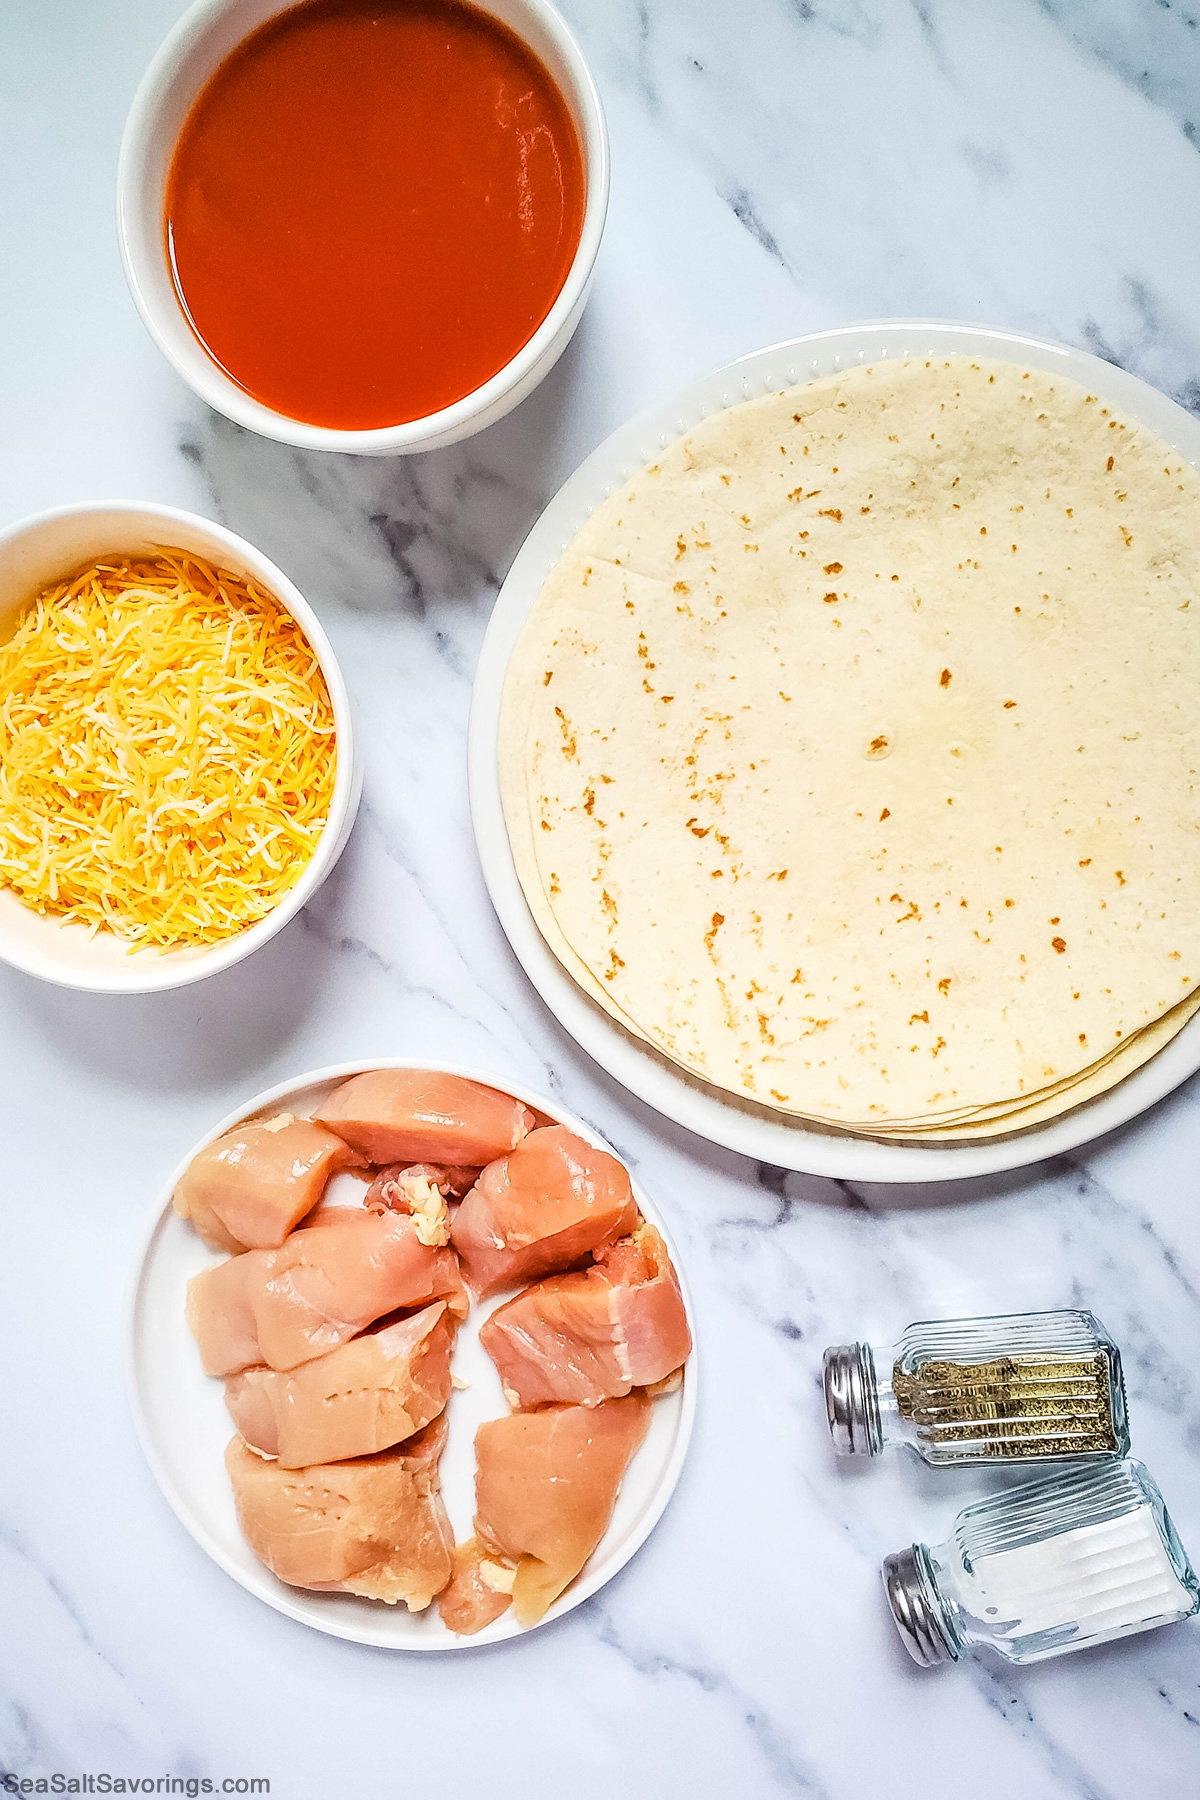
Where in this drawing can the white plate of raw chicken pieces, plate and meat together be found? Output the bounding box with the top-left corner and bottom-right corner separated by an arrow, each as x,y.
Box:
130,1062 -> 694,1651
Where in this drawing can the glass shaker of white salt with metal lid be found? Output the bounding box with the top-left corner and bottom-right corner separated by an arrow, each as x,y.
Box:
883,1462 -> 1200,1669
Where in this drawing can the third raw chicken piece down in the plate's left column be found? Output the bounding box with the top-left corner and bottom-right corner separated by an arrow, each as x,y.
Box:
225,1300 -> 455,1469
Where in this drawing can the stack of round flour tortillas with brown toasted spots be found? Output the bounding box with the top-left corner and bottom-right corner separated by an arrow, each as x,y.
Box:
500,356 -> 1200,1141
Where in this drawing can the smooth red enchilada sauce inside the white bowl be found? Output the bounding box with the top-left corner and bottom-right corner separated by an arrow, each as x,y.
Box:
166,0 -> 583,430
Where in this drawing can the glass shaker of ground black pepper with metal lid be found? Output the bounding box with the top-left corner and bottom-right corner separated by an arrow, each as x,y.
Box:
824,1310 -> 1130,1467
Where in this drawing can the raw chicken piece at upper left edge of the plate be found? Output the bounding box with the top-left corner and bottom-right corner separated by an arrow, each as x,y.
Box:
175,1112 -> 362,1251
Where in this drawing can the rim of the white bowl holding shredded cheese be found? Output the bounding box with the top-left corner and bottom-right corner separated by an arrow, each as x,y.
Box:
0,500 -> 362,994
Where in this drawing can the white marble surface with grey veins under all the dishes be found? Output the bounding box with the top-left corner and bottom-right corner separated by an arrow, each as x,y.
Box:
0,0 -> 1200,1800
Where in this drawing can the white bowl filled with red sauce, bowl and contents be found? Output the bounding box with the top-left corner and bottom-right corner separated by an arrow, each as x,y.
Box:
117,0 -> 608,452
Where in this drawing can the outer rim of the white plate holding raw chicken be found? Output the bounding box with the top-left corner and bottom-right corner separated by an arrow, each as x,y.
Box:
122,1057 -> 698,1656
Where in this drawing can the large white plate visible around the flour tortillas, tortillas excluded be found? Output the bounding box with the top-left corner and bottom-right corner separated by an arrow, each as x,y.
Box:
468,319 -> 1200,1181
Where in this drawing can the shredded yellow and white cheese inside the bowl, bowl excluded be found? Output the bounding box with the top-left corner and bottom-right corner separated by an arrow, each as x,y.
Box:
0,551 -> 336,949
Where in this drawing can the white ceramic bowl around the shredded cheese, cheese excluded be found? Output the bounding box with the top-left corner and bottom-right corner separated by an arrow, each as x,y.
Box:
0,500 -> 362,994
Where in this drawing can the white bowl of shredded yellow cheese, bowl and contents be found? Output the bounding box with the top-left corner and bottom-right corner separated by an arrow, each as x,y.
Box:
0,504 -> 362,994
